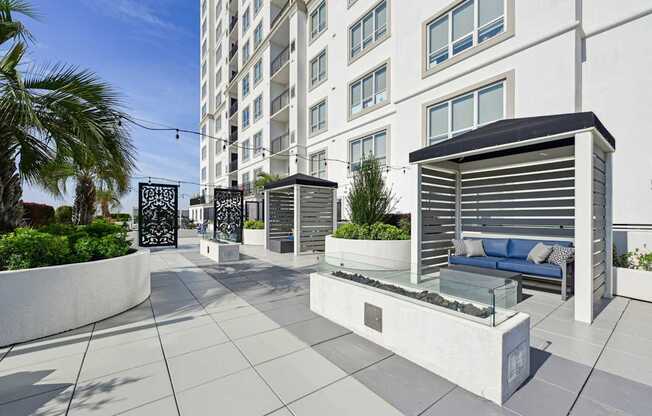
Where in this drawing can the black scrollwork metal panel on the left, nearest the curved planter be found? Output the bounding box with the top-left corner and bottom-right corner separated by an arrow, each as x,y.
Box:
138,183 -> 179,247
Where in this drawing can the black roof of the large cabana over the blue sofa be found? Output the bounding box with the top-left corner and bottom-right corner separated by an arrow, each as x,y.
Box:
410,111 -> 616,163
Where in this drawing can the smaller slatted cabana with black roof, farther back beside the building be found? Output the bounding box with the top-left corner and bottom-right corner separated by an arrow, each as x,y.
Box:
265,174 -> 337,255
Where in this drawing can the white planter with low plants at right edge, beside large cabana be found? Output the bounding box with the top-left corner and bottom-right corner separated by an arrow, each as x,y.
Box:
613,247 -> 652,302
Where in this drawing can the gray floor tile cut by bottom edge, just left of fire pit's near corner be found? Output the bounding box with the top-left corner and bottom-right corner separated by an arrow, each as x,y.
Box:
422,387 -> 518,416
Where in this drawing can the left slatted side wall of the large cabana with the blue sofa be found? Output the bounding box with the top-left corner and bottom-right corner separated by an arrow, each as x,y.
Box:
420,167 -> 456,274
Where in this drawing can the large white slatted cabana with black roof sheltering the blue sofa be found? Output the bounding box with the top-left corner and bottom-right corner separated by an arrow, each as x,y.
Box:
410,112 -> 616,323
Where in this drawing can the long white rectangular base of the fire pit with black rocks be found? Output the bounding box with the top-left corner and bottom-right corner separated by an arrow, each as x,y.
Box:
310,273 -> 530,405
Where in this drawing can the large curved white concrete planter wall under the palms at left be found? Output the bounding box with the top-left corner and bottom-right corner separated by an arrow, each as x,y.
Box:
0,250 -> 150,346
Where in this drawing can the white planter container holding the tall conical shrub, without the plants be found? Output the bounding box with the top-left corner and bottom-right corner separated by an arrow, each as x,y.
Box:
325,235 -> 411,270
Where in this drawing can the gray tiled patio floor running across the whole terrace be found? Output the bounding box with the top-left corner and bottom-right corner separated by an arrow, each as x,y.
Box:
0,239 -> 652,416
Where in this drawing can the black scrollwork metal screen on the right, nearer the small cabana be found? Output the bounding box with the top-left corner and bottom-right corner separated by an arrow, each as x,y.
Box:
213,188 -> 244,243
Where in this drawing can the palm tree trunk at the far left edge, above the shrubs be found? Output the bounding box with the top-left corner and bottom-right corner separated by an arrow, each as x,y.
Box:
0,148 -> 23,234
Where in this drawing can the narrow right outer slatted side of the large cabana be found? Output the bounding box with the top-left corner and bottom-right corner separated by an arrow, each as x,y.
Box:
592,147 -> 609,302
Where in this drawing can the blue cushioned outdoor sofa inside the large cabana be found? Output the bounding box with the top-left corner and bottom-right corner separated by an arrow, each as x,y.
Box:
448,238 -> 573,300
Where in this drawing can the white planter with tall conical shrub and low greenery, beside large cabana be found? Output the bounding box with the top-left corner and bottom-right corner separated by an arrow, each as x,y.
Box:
326,158 -> 410,270
